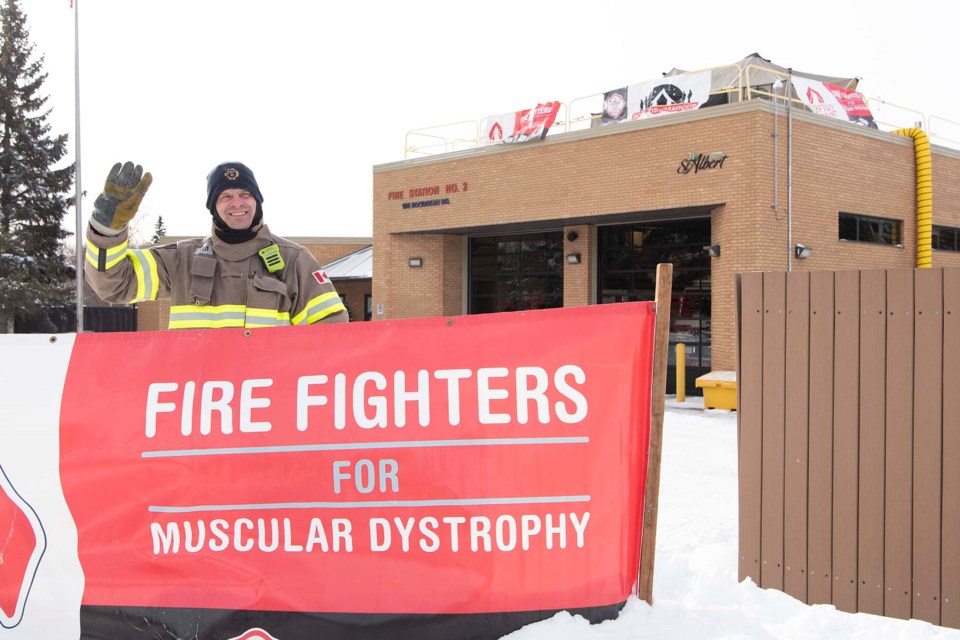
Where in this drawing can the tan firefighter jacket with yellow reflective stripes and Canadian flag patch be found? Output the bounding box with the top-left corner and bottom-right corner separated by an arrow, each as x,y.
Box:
84,225 -> 348,329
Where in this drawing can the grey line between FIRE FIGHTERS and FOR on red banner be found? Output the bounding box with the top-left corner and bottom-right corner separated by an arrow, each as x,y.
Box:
140,436 -> 590,458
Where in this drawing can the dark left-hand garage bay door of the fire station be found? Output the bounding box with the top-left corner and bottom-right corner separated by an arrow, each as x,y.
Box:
469,231 -> 563,314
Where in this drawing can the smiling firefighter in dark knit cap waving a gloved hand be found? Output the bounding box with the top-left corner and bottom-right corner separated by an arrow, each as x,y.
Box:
84,162 -> 349,329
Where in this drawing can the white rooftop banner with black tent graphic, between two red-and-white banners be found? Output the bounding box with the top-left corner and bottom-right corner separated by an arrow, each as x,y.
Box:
600,71 -> 711,125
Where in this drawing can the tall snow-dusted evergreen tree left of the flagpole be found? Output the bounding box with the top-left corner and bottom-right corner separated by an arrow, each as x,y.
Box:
0,0 -> 76,333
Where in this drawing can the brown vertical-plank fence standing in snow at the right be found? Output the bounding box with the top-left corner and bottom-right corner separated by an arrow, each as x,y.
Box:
736,268 -> 960,628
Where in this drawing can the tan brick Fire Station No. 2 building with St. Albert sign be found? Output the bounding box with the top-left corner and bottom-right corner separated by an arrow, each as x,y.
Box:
372,88 -> 960,388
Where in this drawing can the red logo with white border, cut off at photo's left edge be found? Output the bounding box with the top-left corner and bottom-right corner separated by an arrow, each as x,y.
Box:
0,467 -> 46,629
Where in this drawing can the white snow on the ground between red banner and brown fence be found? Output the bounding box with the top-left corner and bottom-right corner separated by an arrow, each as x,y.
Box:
506,396 -> 960,640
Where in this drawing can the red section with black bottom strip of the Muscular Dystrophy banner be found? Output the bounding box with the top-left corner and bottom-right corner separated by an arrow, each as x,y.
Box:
60,303 -> 655,640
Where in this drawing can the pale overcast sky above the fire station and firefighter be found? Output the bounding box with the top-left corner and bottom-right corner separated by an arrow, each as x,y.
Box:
21,0 -> 960,236
